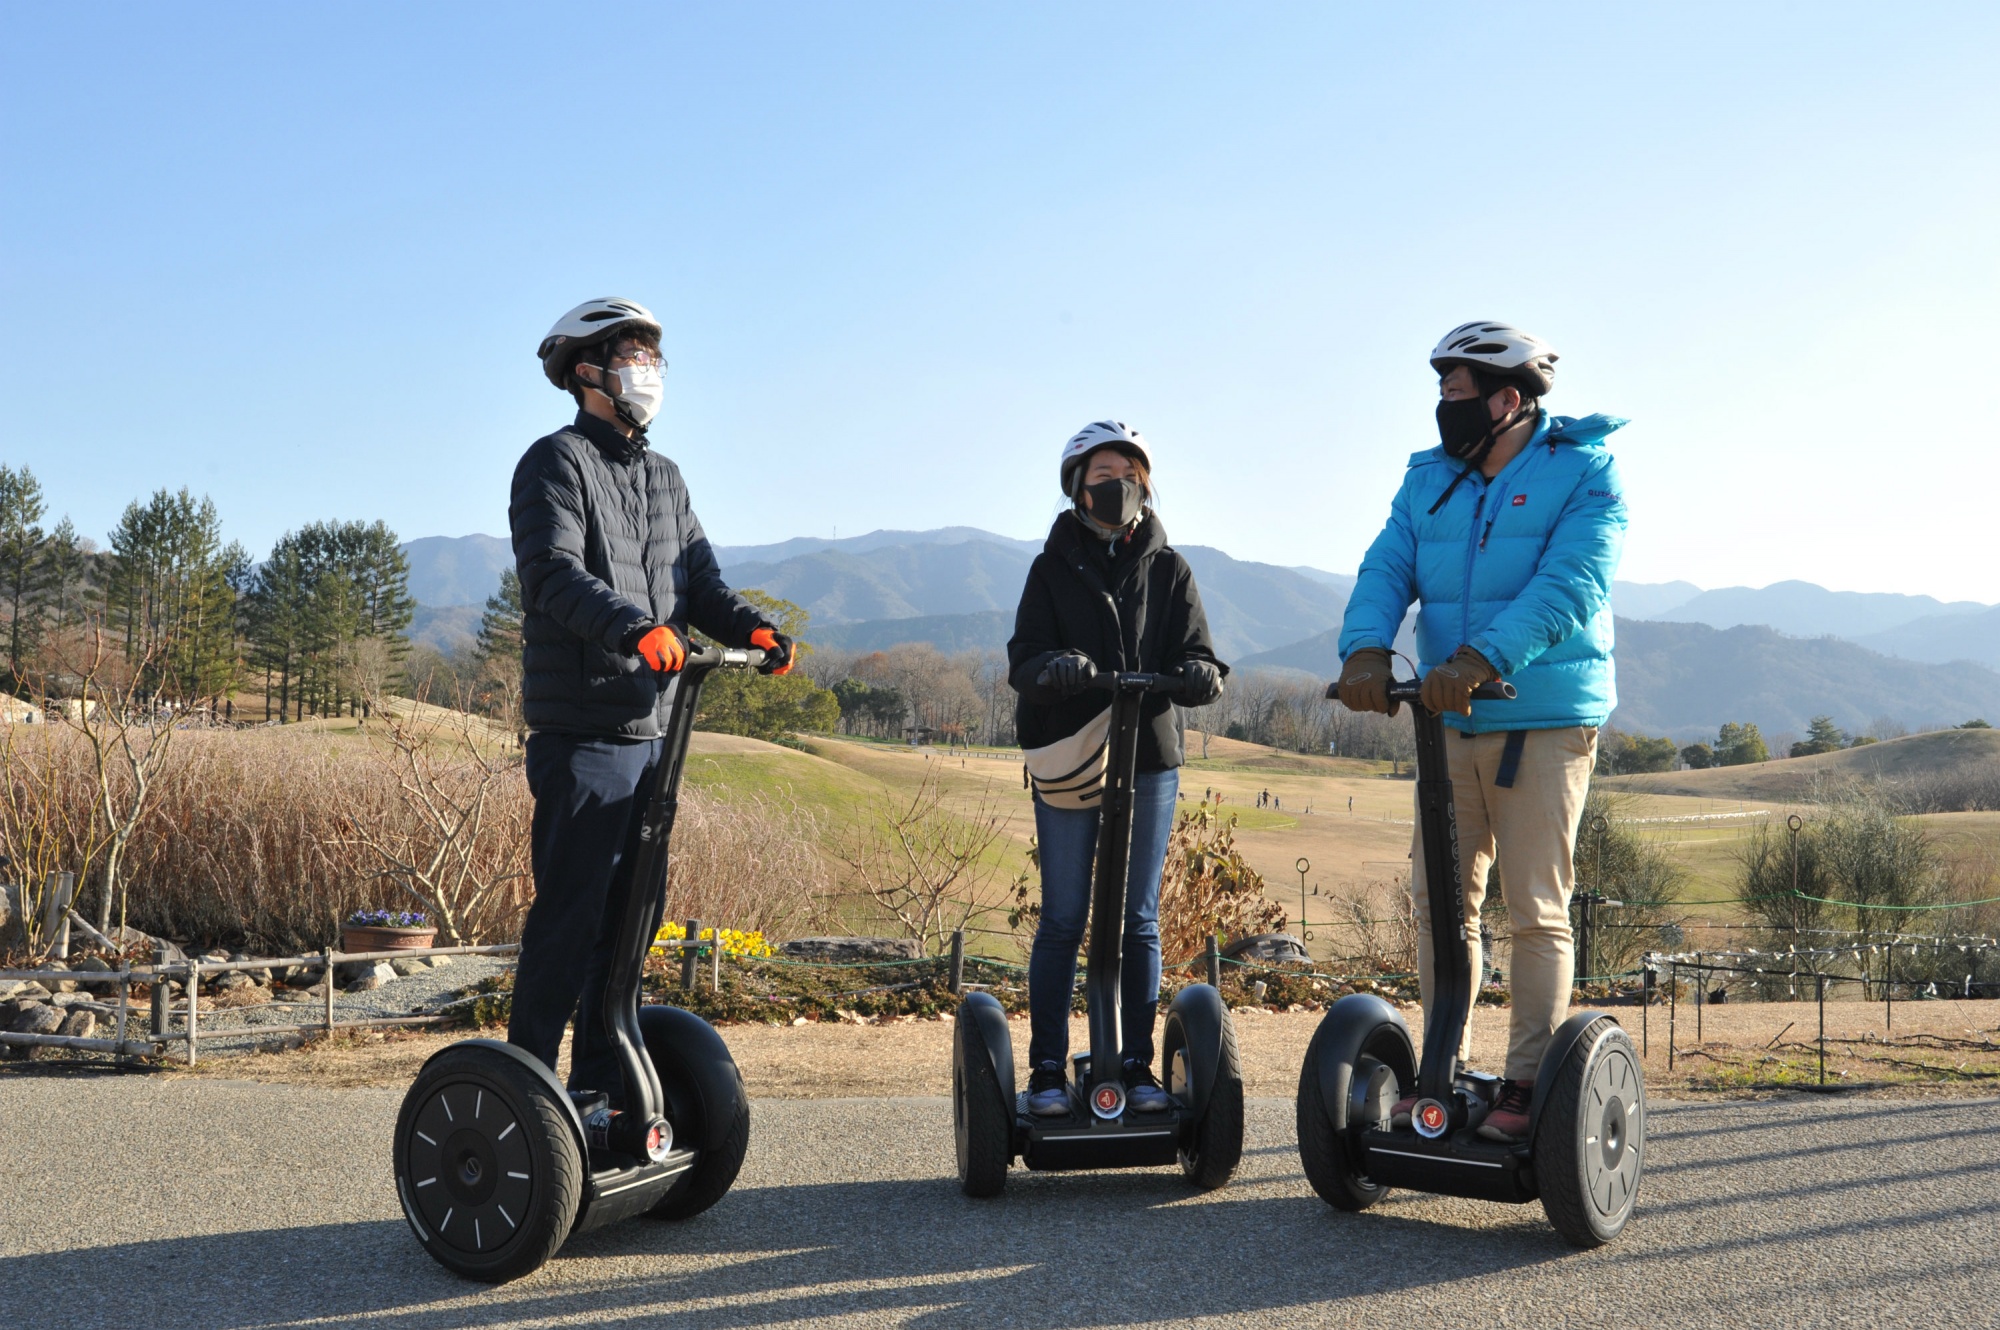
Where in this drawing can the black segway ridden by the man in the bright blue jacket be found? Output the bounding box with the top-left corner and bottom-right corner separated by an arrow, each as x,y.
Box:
1298,680 -> 1646,1248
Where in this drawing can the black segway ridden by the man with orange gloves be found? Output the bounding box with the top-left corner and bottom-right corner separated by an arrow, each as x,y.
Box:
394,646 -> 764,1284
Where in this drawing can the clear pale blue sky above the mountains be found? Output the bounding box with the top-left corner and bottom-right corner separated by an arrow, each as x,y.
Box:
0,4 -> 2000,602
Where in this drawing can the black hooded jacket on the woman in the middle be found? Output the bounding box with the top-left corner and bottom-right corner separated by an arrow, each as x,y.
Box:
1006,512 -> 1230,772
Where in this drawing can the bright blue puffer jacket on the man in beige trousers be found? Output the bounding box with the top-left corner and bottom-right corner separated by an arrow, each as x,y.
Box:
1340,414 -> 1626,734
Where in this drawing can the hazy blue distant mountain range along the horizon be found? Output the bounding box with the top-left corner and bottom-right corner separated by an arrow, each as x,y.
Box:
404,526 -> 2000,738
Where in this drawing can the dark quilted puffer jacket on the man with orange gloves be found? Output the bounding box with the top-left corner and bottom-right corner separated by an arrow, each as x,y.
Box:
508,412 -> 770,738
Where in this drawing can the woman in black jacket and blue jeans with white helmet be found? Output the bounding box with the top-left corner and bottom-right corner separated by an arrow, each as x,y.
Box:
1008,420 -> 1228,1116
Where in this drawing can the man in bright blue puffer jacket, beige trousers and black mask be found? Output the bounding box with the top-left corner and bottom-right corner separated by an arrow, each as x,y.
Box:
1340,322 -> 1626,1140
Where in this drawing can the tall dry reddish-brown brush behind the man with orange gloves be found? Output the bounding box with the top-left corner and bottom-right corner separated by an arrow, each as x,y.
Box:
0,726 -> 828,954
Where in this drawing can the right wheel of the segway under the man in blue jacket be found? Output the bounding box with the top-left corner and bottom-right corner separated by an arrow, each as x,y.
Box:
1534,1018 -> 1646,1248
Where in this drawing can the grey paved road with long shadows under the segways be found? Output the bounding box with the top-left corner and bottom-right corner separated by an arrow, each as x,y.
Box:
0,1076 -> 2000,1330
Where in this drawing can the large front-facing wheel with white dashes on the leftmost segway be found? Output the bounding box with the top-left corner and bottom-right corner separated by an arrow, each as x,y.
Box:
394,1048 -> 584,1284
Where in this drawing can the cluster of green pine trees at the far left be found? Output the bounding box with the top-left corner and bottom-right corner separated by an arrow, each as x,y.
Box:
0,464 -> 416,720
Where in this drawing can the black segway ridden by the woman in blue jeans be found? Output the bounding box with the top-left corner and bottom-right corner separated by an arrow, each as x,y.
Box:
952,672 -> 1244,1196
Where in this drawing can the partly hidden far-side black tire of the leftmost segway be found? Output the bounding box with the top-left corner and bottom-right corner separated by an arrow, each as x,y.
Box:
638,1006 -> 750,1220
